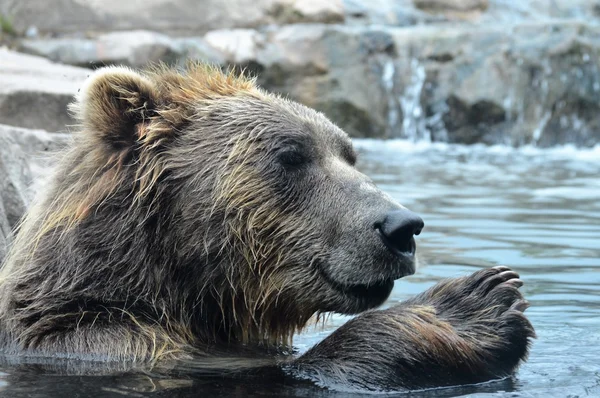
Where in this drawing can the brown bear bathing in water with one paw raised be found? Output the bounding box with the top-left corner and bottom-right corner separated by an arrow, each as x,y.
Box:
0,64 -> 534,390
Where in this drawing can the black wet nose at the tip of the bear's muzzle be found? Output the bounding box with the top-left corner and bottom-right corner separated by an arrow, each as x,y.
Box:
375,209 -> 425,254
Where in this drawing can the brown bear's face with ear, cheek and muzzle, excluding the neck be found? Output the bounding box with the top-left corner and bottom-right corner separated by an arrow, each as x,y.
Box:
75,67 -> 422,334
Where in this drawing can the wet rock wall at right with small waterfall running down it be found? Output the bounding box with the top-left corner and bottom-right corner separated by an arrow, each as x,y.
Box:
384,21 -> 600,146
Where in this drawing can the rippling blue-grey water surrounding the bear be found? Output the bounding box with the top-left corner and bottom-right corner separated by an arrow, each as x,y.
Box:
0,140 -> 600,398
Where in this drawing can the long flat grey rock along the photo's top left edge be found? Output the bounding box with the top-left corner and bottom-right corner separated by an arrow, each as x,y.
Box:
0,0 -> 344,36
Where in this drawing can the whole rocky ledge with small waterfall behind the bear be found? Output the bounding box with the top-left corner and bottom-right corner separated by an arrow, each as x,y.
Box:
0,0 -> 600,146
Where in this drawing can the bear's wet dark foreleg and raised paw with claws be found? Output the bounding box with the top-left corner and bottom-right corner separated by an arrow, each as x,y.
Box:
289,267 -> 535,390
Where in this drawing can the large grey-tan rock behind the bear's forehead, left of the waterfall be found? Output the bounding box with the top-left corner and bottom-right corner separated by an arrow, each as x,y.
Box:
244,24 -> 393,137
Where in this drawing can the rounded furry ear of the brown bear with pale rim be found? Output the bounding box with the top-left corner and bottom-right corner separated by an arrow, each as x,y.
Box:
70,67 -> 158,148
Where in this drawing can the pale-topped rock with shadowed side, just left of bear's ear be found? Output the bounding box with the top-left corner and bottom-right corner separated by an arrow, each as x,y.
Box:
0,49 -> 90,131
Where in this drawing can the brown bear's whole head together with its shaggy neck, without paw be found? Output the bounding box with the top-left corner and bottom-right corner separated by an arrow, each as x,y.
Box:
9,65 -> 423,341
